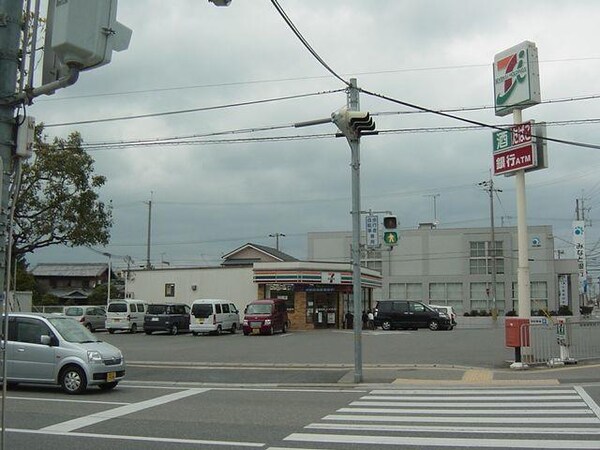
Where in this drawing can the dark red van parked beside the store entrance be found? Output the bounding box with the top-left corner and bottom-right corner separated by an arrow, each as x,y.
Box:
242,298 -> 290,336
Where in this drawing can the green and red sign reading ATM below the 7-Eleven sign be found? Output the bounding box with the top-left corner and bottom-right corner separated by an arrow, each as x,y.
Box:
493,121 -> 537,175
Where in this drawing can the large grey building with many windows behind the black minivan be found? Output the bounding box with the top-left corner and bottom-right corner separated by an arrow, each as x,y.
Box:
308,224 -> 579,314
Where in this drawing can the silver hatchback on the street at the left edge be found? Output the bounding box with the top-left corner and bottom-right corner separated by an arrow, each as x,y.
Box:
0,313 -> 125,394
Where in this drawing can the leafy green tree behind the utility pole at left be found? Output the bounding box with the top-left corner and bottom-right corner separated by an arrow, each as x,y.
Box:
13,125 -> 112,257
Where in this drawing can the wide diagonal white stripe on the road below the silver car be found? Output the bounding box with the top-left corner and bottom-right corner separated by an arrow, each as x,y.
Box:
40,389 -> 210,433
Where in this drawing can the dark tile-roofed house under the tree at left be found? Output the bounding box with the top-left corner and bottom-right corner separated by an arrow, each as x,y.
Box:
31,263 -> 114,304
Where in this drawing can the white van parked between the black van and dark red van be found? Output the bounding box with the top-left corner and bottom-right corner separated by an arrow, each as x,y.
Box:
190,299 -> 240,336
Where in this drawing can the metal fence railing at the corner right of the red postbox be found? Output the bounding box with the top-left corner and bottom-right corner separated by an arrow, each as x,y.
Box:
520,318 -> 600,366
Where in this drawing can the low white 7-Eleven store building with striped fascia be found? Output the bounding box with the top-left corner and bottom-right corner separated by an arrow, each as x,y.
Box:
126,243 -> 381,329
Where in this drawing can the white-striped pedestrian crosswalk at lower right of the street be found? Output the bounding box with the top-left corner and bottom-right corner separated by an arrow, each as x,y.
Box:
269,386 -> 600,450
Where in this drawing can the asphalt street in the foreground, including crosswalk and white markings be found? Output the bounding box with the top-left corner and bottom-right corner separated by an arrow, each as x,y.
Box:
6,383 -> 600,450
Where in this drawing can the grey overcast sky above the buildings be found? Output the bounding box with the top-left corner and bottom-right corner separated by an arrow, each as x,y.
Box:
28,0 -> 600,267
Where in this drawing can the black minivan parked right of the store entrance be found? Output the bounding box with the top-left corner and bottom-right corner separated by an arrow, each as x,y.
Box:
375,300 -> 452,331
